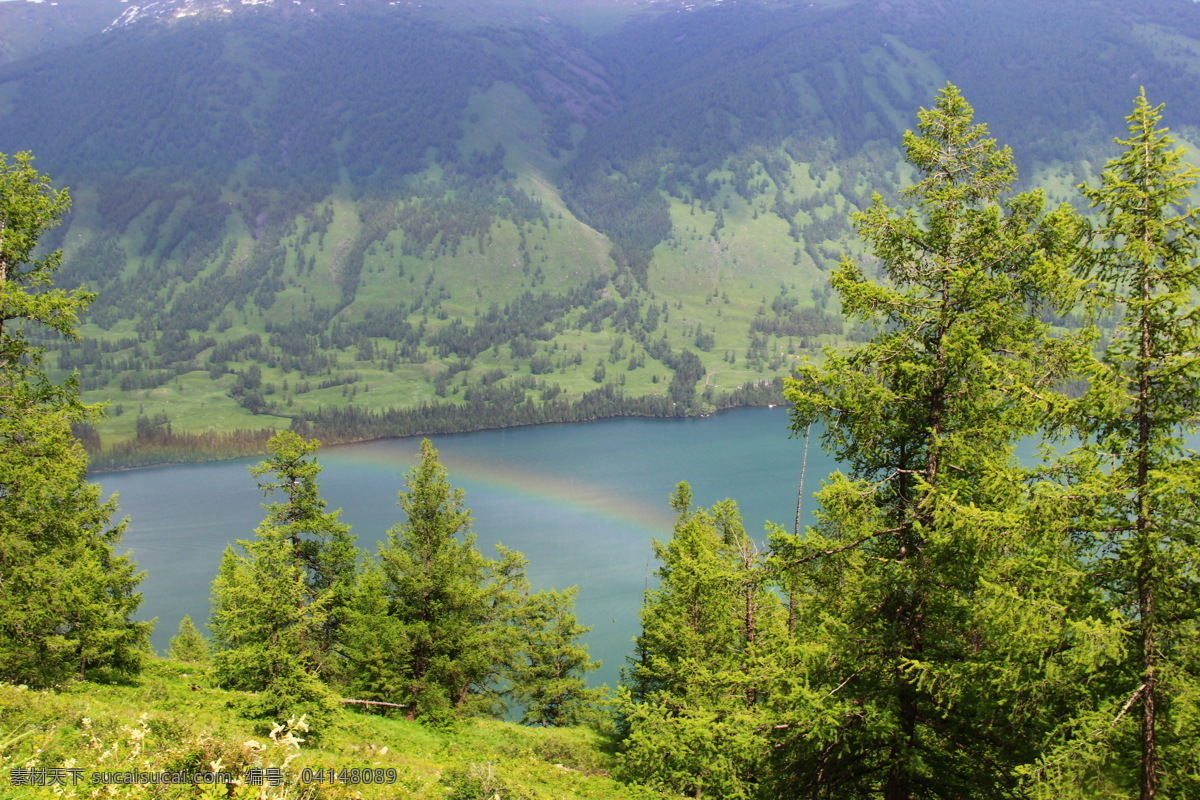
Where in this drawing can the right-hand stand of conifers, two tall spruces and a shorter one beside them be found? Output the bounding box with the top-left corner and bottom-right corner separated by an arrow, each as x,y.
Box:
618,86 -> 1200,800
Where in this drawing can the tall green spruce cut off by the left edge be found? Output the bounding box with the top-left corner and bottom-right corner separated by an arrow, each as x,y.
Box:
0,154 -> 151,686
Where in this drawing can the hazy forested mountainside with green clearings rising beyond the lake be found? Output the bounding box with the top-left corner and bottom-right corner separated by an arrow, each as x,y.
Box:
0,0 -> 1200,464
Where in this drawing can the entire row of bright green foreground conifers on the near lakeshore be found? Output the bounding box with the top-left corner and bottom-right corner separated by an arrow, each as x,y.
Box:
0,85 -> 1200,800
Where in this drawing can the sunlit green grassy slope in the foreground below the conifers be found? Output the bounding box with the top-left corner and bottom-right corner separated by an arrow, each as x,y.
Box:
0,660 -> 661,800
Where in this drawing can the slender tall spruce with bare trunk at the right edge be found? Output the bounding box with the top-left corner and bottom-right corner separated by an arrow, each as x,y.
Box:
1040,92 -> 1200,800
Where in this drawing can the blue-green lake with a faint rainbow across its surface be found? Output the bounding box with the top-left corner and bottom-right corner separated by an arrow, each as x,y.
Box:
95,408 -> 834,685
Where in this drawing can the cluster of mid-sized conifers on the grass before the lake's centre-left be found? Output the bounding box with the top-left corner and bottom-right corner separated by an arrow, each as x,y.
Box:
201,432 -> 596,724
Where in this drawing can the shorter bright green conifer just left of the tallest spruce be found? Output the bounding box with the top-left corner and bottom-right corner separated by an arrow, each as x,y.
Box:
618,483 -> 784,798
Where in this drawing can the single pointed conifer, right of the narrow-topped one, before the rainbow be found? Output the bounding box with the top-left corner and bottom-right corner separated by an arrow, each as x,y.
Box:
348,439 -> 528,721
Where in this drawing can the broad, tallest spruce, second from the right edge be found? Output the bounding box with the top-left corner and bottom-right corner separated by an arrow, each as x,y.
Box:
768,86 -> 1094,800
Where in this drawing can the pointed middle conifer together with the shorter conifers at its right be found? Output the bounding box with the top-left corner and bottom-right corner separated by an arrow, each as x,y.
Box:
347,439 -> 593,724
